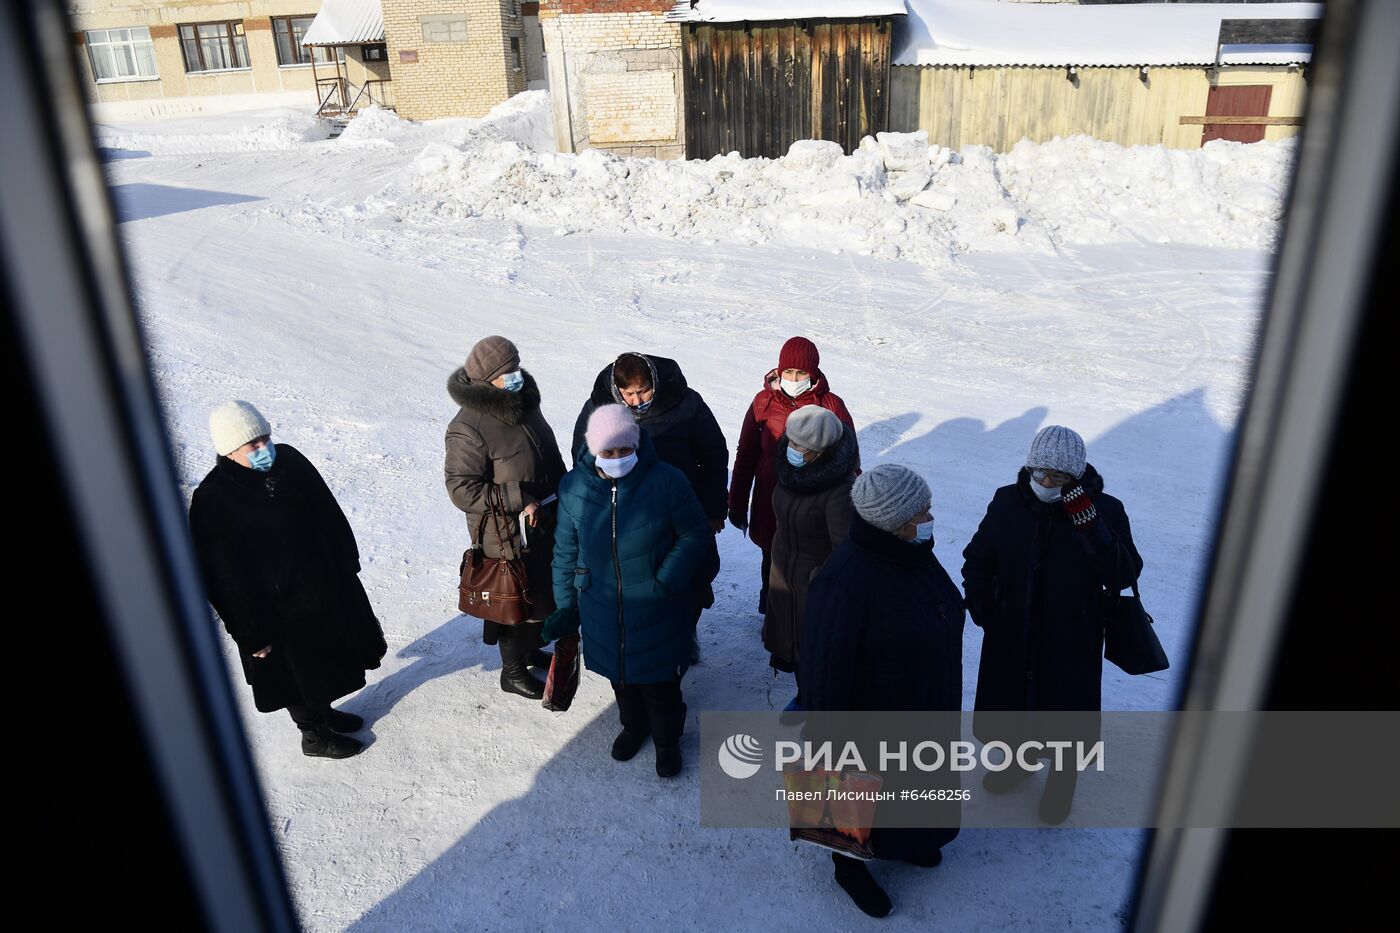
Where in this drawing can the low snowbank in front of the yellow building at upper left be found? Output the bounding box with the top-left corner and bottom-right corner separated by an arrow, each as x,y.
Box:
92,108 -> 330,156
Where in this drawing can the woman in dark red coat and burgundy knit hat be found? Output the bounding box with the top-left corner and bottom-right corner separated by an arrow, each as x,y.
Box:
729,336 -> 860,615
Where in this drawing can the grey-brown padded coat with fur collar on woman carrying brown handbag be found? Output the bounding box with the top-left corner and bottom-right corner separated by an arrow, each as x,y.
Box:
444,368 -> 564,624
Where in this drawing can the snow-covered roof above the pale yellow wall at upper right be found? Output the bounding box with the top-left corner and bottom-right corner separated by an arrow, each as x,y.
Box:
895,0 -> 1322,66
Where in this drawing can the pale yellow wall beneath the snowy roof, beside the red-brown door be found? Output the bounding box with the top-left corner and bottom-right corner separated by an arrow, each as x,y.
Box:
889,66 -> 1306,153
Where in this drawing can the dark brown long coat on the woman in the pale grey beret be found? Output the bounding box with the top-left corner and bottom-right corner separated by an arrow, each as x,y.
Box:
763,427 -> 858,671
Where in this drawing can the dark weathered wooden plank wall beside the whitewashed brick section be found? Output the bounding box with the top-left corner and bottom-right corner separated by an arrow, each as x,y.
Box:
682,18 -> 890,158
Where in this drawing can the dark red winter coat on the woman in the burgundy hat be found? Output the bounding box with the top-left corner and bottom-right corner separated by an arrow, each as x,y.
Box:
729,370 -> 855,551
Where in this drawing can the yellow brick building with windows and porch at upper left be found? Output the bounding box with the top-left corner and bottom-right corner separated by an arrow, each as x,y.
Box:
69,0 -> 546,119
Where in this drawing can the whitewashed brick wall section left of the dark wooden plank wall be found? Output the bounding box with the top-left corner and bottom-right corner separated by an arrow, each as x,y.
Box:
540,0 -> 685,158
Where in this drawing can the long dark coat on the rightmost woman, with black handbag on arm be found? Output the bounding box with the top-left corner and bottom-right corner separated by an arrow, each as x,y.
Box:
963,465 -> 1142,738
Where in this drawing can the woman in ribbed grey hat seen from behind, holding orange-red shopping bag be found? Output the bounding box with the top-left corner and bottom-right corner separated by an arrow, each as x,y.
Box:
798,464 -> 963,916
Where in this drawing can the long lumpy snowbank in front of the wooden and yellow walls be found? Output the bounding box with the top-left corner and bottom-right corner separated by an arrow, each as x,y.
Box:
378,113 -> 1295,266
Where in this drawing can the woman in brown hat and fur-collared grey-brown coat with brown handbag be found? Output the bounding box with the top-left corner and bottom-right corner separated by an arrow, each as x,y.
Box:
444,336 -> 564,699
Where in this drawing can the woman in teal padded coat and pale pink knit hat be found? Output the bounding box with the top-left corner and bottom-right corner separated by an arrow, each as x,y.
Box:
534,405 -> 715,778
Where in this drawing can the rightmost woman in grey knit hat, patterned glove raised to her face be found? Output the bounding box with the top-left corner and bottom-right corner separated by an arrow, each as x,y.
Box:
963,424 -> 1142,822
